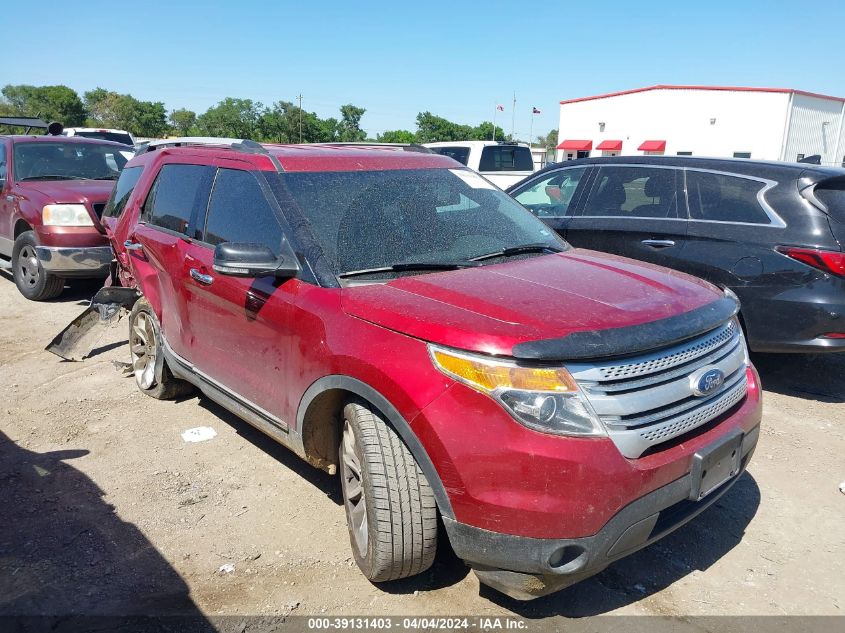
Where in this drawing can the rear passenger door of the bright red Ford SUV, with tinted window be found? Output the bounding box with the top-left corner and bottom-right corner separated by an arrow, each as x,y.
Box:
125,162 -> 214,357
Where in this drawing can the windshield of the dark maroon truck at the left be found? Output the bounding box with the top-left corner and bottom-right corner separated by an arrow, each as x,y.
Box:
14,141 -> 131,180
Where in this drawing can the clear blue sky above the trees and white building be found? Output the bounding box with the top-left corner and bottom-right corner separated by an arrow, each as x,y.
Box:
8,0 -> 845,138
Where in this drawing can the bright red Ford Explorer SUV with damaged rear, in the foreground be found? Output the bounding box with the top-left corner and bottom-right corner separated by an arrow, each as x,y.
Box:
95,139 -> 761,599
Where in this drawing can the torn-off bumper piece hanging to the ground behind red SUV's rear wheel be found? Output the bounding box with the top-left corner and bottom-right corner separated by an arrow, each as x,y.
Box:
45,286 -> 141,361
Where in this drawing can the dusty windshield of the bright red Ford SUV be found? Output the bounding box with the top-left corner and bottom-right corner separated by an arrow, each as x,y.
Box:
270,169 -> 567,274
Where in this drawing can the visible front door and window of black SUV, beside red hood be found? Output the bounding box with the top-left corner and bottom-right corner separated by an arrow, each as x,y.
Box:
510,165 -> 590,238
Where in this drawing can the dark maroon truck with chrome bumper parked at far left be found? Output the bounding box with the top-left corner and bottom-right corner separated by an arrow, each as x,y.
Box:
0,136 -> 132,301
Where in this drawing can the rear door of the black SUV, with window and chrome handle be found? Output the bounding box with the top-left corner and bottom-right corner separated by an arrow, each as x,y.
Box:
566,164 -> 687,268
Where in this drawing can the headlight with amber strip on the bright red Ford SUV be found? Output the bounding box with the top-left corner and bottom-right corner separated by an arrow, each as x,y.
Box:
429,345 -> 607,436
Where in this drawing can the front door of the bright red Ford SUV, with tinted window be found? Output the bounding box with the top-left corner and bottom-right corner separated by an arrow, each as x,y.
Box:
182,159 -> 294,428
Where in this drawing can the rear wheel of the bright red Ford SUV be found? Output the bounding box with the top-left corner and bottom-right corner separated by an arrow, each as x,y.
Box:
129,297 -> 194,400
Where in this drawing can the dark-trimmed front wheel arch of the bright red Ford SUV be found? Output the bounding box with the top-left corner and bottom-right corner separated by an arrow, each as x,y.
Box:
296,374 -> 455,519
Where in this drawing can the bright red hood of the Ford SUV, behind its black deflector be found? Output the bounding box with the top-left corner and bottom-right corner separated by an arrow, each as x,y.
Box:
342,249 -> 730,358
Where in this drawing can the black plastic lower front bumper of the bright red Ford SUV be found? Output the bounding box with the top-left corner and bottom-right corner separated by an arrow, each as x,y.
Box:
443,425 -> 760,600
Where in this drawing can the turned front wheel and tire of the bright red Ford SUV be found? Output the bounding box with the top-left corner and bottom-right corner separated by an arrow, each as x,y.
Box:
338,402 -> 437,582
